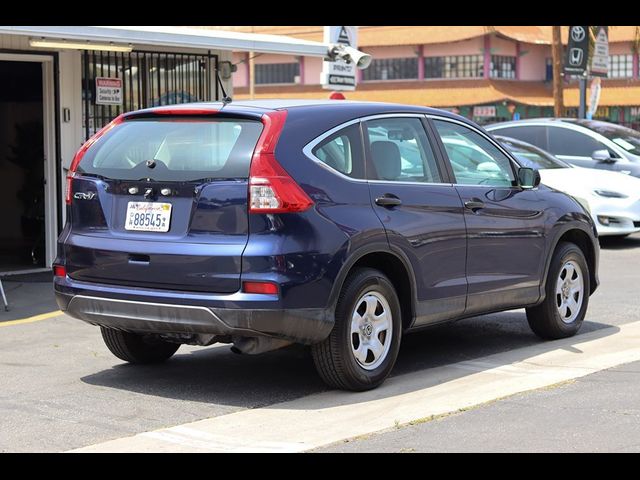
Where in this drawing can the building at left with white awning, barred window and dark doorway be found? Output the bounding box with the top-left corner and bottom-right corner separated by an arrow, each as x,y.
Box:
0,26 -> 327,273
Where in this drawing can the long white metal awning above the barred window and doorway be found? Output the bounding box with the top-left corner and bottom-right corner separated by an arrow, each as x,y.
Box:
0,26 -> 327,57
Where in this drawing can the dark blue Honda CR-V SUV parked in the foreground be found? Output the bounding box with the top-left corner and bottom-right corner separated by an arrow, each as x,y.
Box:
54,100 -> 599,390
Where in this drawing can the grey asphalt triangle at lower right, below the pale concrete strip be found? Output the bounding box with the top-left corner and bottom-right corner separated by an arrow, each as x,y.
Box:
316,362 -> 640,453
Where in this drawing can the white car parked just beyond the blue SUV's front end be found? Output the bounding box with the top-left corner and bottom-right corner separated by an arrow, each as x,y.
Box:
495,135 -> 640,237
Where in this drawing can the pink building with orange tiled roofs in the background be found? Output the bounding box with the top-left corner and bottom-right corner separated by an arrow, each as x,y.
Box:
225,26 -> 640,128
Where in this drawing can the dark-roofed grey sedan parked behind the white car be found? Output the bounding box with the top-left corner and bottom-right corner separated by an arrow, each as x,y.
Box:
485,118 -> 640,177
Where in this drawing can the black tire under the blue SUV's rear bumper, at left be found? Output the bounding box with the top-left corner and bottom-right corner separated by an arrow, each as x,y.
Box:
100,327 -> 180,364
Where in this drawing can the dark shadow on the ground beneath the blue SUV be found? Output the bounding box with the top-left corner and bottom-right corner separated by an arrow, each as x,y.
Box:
81,310 -> 618,408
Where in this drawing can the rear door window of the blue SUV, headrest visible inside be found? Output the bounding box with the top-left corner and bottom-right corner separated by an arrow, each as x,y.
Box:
366,118 -> 442,183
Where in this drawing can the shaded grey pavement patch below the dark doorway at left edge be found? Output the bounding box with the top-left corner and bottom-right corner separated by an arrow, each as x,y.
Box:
0,272 -> 58,323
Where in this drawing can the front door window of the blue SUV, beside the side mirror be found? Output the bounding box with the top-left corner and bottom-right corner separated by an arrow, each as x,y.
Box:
433,120 -> 516,187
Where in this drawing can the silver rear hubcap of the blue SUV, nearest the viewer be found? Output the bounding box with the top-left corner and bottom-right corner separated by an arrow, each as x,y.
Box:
351,292 -> 393,370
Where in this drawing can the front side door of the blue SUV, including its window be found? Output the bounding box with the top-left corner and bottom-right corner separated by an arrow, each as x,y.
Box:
433,118 -> 545,314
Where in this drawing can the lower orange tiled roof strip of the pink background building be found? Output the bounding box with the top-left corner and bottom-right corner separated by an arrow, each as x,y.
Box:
234,80 -> 640,108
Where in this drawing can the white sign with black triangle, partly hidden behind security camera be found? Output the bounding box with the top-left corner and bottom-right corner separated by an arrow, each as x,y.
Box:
320,26 -> 358,90
